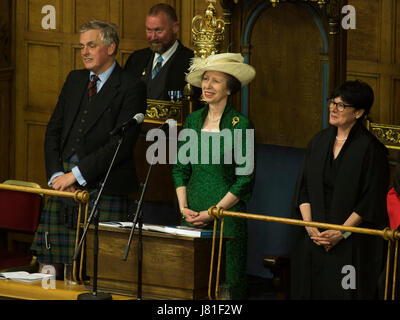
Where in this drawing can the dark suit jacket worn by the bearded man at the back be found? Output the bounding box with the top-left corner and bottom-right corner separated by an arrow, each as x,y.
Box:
125,42 -> 194,100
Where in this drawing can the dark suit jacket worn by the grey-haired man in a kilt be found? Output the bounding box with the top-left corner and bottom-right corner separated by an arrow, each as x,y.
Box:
45,64 -> 146,194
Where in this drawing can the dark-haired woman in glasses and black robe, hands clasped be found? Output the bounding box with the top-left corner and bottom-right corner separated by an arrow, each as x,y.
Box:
291,81 -> 389,299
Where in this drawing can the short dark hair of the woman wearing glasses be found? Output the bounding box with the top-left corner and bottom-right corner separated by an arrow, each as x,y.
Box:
330,80 -> 374,117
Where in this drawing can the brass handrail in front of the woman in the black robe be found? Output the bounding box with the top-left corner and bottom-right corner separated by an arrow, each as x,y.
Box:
208,206 -> 400,300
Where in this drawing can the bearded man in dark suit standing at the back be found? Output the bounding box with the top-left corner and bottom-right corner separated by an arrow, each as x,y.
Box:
125,3 -> 194,100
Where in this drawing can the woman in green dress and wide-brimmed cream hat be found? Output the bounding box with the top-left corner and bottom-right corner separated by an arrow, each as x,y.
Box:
173,53 -> 255,299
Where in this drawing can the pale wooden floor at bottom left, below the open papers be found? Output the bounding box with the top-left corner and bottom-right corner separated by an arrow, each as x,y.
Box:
0,279 -> 136,300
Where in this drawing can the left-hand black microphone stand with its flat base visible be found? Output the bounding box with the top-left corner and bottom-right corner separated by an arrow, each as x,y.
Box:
72,128 -> 126,300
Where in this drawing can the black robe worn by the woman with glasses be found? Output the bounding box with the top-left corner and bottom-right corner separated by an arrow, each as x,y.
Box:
291,123 -> 389,299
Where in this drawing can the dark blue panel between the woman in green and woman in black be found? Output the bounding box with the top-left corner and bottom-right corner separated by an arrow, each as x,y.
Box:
247,145 -> 304,278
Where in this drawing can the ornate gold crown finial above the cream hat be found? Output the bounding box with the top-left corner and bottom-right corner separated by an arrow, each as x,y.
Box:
192,0 -> 225,58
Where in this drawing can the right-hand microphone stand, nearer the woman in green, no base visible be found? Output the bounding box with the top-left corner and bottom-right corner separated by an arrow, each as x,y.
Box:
122,150 -> 154,300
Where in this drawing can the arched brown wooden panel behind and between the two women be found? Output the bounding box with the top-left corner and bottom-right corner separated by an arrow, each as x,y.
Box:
248,3 -> 323,147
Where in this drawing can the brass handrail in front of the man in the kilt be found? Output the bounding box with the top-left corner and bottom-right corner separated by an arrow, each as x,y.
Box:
0,183 -> 89,282
